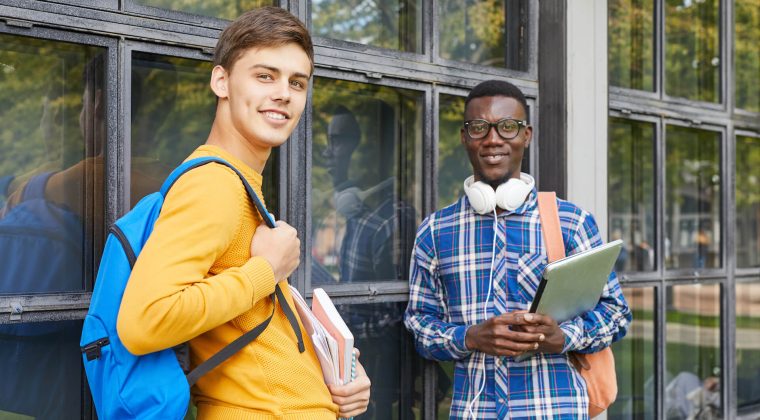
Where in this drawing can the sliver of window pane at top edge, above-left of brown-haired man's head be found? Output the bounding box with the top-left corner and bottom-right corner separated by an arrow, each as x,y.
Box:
135,0 -> 280,20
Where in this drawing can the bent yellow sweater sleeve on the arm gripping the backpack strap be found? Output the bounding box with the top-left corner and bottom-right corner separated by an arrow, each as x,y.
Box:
117,165 -> 275,355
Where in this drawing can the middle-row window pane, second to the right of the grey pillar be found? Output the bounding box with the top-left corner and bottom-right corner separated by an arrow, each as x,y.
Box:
665,126 -> 721,268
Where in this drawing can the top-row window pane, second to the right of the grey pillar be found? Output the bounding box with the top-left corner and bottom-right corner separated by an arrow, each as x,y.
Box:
665,0 -> 720,102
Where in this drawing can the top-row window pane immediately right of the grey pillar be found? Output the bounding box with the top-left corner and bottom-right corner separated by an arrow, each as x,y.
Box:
607,0 -> 654,91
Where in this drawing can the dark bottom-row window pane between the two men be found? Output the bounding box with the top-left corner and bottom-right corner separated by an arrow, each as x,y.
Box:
338,302 -> 424,420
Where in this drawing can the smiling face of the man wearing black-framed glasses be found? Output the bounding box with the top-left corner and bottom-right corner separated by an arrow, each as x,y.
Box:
460,96 -> 533,189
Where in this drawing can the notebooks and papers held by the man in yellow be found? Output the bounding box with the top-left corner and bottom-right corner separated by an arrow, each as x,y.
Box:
290,286 -> 354,385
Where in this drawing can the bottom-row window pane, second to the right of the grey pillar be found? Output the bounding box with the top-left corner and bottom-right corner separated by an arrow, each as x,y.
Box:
665,284 -> 723,419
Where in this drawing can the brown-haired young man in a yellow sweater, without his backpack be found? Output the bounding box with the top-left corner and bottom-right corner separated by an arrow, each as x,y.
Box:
118,7 -> 370,419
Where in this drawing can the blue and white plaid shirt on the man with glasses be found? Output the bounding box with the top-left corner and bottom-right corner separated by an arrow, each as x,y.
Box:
405,190 -> 631,419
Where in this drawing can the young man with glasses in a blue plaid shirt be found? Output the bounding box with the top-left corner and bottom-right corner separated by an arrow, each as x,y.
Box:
405,80 -> 631,419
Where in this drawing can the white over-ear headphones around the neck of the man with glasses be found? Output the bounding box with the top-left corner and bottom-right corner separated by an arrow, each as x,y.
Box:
464,173 -> 536,214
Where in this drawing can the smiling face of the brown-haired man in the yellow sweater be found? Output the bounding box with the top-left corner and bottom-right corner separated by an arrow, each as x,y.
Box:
211,43 -> 311,150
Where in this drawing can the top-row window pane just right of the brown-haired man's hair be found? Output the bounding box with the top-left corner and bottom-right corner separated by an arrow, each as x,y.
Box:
311,0 -> 422,53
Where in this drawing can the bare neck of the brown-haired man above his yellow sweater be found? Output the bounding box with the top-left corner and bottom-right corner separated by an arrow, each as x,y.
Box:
206,107 -> 272,174
